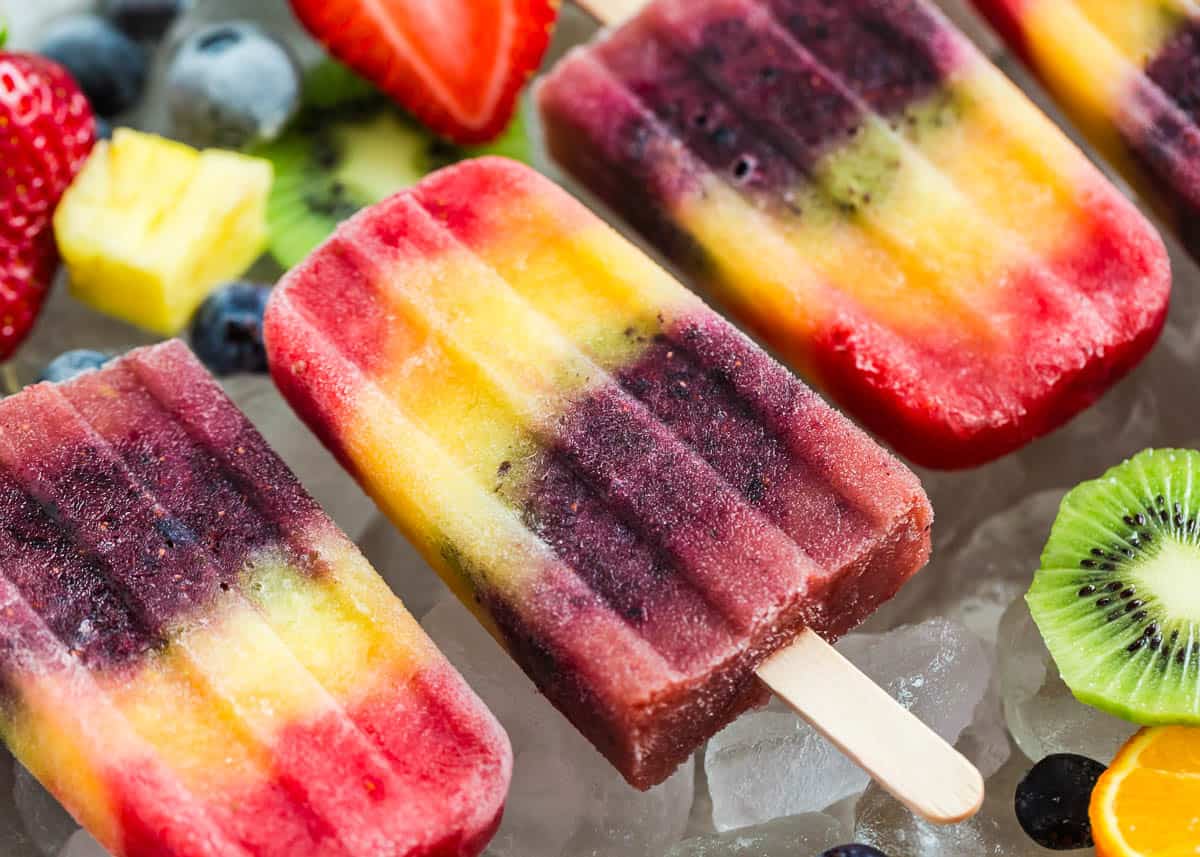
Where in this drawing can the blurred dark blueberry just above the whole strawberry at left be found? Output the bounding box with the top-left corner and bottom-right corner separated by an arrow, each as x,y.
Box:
38,14 -> 148,116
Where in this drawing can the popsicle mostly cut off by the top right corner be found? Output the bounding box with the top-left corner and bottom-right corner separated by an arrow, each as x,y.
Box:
976,0 -> 1200,258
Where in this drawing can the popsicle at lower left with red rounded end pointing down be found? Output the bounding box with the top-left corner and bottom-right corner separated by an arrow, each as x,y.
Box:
0,342 -> 510,857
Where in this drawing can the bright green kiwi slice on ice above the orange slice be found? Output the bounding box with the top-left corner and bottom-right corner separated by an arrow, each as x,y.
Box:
1026,449 -> 1200,725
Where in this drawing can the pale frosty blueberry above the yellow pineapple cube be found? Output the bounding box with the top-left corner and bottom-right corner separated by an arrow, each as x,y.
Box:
167,22 -> 300,149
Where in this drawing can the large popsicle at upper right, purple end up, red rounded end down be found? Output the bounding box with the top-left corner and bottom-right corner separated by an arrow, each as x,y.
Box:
540,0 -> 1170,467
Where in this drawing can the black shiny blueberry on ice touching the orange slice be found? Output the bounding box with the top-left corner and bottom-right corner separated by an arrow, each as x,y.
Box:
1016,753 -> 1104,851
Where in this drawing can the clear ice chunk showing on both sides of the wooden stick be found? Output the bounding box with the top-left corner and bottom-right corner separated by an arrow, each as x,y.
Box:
704,619 -> 991,831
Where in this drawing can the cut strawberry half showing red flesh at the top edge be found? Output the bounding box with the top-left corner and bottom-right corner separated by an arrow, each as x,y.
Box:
292,0 -> 560,144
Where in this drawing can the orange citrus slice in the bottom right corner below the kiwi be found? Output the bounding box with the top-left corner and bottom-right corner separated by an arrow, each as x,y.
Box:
1090,726 -> 1200,857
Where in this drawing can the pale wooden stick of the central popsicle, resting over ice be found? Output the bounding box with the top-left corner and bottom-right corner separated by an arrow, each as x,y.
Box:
758,629 -> 984,825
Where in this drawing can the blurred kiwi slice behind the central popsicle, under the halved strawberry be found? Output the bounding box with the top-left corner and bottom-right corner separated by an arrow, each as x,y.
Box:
253,61 -> 532,268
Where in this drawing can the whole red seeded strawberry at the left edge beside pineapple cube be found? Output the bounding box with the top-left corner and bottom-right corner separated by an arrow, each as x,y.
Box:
0,52 -> 96,360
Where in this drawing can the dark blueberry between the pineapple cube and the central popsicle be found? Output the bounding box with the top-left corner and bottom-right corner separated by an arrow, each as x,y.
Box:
192,283 -> 271,374
